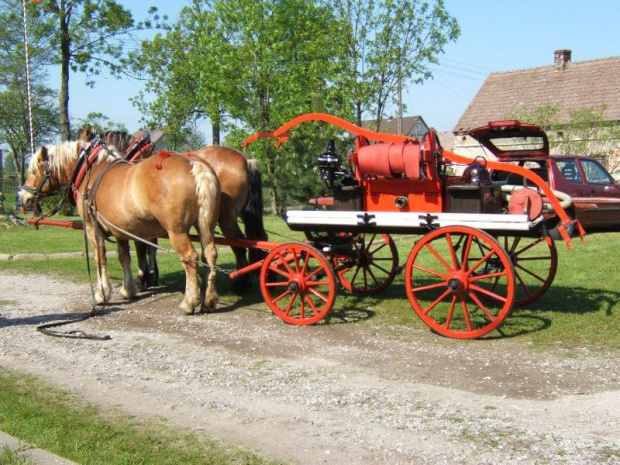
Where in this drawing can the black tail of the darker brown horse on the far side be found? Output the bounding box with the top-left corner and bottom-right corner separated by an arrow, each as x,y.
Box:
241,158 -> 268,263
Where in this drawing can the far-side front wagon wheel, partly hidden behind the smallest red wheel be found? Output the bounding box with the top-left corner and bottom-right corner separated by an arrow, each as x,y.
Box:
329,234 -> 398,295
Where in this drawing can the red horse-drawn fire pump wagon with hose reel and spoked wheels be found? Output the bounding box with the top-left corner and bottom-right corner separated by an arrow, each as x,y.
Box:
24,113 -> 585,338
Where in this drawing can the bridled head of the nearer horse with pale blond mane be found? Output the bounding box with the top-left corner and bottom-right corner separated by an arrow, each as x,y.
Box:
19,142 -> 83,211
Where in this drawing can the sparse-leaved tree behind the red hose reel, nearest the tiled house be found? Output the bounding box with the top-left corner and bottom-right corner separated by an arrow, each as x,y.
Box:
332,0 -> 460,130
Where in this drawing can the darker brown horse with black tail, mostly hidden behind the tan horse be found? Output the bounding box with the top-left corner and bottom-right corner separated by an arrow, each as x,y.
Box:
80,128 -> 267,292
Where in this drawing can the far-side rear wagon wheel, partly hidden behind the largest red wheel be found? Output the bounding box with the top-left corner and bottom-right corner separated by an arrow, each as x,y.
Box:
468,236 -> 558,306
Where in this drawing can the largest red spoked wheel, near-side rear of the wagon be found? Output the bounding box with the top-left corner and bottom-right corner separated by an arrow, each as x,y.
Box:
405,226 -> 515,339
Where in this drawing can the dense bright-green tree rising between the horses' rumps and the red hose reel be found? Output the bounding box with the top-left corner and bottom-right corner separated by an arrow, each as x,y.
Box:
214,0 -> 344,213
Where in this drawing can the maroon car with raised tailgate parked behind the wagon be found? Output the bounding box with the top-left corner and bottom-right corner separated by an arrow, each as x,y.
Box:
469,121 -> 620,235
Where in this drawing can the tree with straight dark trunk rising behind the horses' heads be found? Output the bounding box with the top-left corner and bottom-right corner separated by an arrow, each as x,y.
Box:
36,0 -> 159,140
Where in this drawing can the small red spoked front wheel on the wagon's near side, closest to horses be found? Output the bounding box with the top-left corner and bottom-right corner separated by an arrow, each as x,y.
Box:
260,244 -> 336,325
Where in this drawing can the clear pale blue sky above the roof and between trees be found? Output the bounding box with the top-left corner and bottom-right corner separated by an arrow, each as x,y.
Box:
51,0 -> 620,138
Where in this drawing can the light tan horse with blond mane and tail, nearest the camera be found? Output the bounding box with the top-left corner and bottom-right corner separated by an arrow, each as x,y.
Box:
19,142 -> 221,313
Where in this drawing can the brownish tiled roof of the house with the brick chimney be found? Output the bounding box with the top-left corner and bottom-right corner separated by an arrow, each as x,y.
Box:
454,57 -> 620,132
